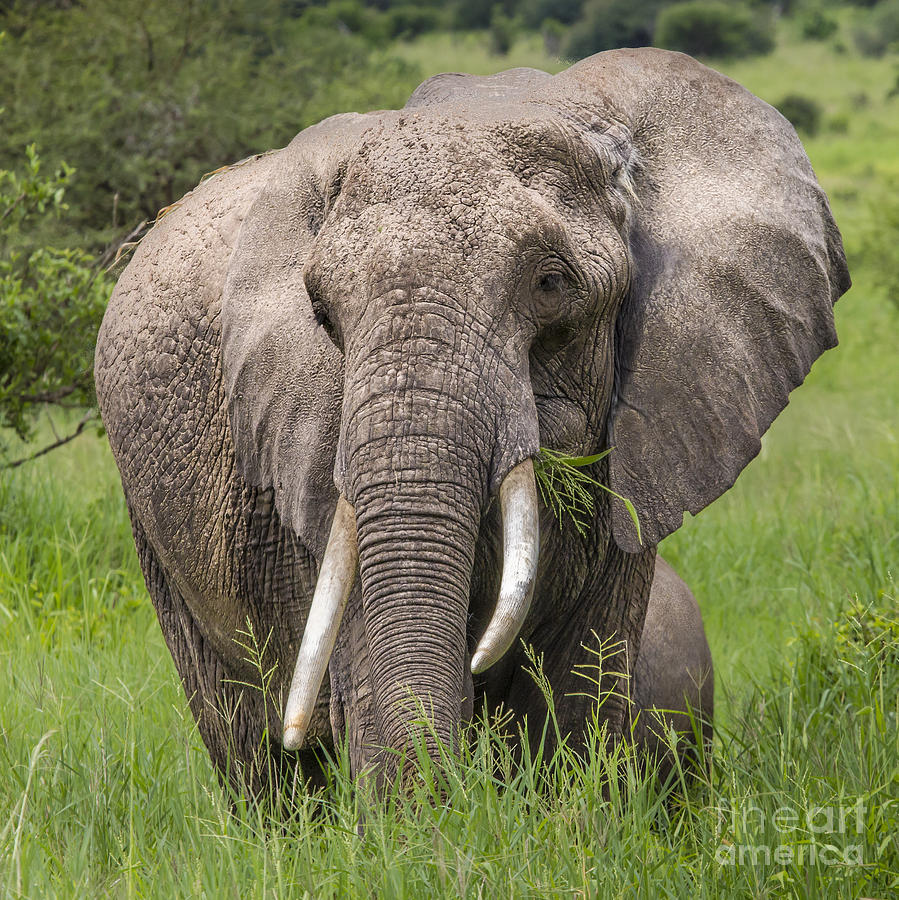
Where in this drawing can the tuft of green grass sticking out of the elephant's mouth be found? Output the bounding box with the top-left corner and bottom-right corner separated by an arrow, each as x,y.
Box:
534,447 -> 643,544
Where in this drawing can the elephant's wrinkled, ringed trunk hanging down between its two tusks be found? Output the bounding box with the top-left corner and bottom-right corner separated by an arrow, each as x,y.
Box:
339,336 -> 488,760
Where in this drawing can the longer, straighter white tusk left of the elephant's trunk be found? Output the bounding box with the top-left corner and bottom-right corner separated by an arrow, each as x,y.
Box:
282,497 -> 359,750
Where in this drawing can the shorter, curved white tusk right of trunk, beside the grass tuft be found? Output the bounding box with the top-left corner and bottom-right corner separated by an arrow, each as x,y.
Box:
471,459 -> 540,675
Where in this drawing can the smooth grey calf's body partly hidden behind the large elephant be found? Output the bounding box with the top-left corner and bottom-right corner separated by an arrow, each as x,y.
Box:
633,557 -> 715,776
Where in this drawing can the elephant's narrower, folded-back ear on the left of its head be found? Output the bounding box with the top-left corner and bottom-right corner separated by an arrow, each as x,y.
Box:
222,113 -> 383,559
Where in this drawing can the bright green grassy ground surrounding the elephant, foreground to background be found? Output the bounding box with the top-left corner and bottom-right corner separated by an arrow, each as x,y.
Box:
0,12 -> 899,898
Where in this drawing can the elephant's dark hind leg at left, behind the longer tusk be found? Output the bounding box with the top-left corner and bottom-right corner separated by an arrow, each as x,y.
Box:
129,509 -> 325,799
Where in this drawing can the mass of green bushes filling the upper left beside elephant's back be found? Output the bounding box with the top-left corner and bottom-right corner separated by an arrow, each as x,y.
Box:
0,0 -> 426,458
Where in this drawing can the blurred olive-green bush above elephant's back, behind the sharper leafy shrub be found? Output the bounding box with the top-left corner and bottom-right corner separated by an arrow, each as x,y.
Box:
0,0 -> 417,248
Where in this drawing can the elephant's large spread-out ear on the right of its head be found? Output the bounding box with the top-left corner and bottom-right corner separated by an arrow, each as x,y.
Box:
558,50 -> 850,551
